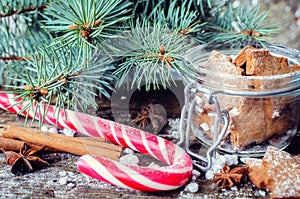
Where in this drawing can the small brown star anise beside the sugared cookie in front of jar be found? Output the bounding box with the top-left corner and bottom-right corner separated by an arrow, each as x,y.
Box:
213,165 -> 248,189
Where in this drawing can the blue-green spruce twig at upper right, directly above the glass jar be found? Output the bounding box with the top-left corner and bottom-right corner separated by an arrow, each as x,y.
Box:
199,4 -> 279,46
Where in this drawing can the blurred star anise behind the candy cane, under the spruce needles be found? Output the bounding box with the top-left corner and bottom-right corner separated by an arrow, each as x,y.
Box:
132,104 -> 166,132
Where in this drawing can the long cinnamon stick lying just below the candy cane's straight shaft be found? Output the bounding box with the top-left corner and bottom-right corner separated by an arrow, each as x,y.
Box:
0,125 -> 122,160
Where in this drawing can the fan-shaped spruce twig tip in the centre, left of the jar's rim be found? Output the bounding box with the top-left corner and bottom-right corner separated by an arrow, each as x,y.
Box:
102,20 -> 195,90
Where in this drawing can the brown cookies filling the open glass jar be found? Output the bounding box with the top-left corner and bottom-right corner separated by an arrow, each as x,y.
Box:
192,46 -> 300,152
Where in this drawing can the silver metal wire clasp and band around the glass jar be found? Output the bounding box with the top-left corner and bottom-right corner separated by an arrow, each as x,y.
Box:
177,80 -> 300,171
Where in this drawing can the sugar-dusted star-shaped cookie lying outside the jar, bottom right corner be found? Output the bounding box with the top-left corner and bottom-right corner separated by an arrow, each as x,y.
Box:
244,147 -> 300,198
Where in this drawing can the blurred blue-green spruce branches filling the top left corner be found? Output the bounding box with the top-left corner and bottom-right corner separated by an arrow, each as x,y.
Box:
0,0 -> 52,85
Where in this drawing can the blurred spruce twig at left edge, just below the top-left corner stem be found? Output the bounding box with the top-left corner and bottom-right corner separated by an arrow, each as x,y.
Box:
0,10 -> 52,87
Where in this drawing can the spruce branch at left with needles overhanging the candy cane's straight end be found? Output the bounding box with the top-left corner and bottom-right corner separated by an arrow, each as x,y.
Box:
6,46 -> 113,123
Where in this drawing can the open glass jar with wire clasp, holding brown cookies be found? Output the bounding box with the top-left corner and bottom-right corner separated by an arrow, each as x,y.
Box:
179,44 -> 300,170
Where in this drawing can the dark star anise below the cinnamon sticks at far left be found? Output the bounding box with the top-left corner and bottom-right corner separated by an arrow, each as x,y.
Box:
2,143 -> 49,175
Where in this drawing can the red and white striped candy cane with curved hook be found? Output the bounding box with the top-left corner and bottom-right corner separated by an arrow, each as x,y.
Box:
0,93 -> 193,191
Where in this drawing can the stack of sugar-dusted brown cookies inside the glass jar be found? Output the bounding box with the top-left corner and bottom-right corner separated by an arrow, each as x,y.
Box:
194,46 -> 300,151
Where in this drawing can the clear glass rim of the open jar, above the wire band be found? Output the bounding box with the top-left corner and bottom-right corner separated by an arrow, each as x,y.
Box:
185,43 -> 300,96
